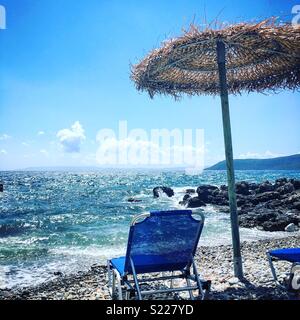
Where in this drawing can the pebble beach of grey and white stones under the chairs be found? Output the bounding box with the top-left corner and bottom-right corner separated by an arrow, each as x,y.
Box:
0,232 -> 300,300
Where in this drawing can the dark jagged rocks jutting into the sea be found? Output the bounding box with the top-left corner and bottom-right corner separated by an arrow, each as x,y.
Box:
153,178 -> 300,232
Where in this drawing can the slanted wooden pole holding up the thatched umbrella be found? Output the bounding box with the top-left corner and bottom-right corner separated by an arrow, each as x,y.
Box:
217,40 -> 243,278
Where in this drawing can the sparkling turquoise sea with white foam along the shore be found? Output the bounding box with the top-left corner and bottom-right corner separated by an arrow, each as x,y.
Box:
0,170 -> 300,289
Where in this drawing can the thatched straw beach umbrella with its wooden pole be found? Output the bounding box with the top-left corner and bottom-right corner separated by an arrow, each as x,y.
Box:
131,20 -> 300,278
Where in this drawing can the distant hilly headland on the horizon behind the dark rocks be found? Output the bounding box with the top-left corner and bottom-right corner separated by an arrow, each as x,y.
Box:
205,154 -> 300,170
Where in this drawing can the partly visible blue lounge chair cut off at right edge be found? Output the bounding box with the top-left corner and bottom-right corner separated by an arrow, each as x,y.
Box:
267,248 -> 300,291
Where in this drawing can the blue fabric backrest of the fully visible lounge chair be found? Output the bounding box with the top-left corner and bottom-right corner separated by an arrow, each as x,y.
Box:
125,210 -> 204,274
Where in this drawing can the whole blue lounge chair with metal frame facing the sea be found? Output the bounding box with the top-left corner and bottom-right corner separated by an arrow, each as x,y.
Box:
108,210 -> 210,300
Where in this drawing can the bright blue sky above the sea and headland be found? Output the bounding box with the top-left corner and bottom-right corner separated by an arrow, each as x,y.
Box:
0,0 -> 300,170
